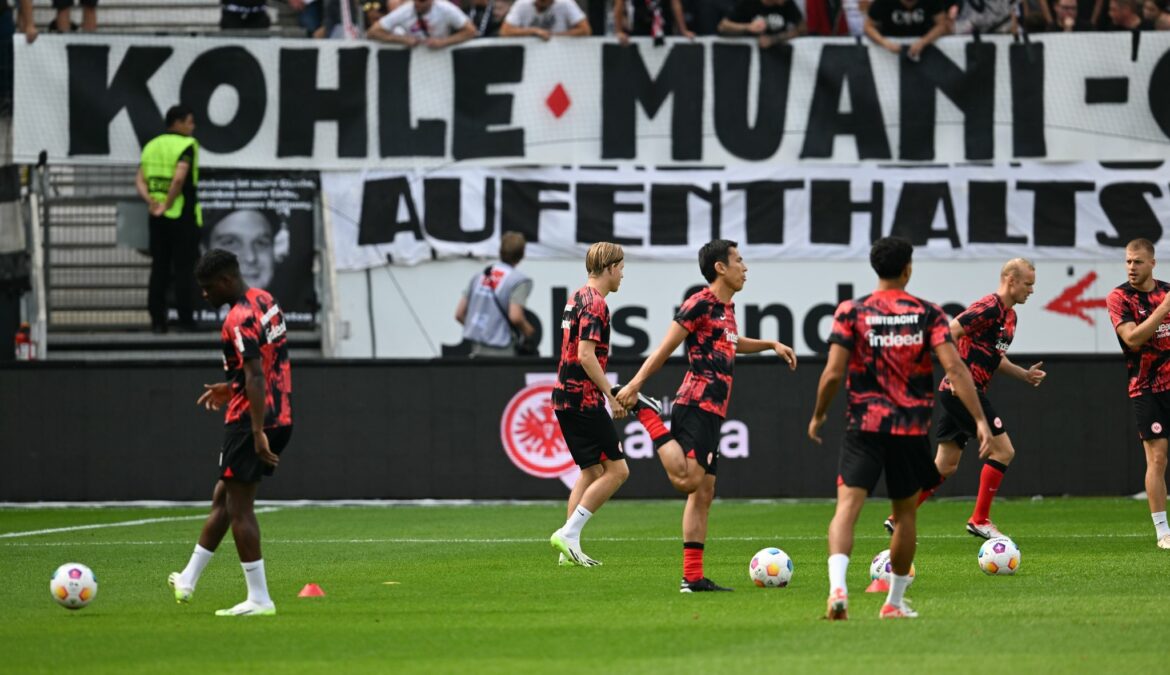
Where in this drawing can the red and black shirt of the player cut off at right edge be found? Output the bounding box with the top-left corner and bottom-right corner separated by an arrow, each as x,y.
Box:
1106,280 -> 1170,398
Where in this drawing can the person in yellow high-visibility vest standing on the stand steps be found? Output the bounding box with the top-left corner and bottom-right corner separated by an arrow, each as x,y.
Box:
135,105 -> 204,333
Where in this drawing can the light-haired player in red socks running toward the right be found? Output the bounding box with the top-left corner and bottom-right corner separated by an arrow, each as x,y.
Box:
886,257 -> 1047,539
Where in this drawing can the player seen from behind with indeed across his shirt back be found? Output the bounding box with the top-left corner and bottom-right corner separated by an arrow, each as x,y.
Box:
808,236 -> 991,620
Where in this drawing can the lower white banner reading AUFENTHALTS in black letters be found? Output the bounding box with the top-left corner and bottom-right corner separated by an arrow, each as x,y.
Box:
322,161 -> 1170,270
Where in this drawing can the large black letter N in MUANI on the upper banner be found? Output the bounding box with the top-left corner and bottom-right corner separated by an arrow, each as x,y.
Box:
899,42 -> 996,160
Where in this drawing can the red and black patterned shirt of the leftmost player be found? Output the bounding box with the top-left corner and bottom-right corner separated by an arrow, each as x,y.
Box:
220,288 -> 293,428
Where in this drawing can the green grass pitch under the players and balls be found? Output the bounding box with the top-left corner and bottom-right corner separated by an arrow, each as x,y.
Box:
0,498 -> 1170,675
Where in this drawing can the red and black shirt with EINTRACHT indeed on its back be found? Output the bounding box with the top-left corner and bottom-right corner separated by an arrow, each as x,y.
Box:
828,290 -> 951,436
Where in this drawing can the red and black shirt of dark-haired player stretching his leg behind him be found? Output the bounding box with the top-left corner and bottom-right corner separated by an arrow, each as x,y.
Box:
674,288 -> 739,418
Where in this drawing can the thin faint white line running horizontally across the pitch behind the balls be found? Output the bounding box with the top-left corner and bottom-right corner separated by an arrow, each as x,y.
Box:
0,531 -> 1149,547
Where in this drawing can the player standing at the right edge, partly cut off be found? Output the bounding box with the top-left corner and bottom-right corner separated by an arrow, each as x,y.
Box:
1106,239 -> 1170,549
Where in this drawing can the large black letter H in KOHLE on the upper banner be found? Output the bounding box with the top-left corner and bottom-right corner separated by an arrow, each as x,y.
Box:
276,47 -> 370,157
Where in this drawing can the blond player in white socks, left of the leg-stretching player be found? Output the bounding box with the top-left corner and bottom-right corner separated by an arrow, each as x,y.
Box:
549,241 -> 629,567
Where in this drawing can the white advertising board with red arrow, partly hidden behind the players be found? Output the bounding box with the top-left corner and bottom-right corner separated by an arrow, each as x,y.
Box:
326,252 -> 1126,357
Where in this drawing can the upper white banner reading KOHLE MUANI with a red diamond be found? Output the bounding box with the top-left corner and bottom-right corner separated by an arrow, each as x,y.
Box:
13,32 -> 1170,171
